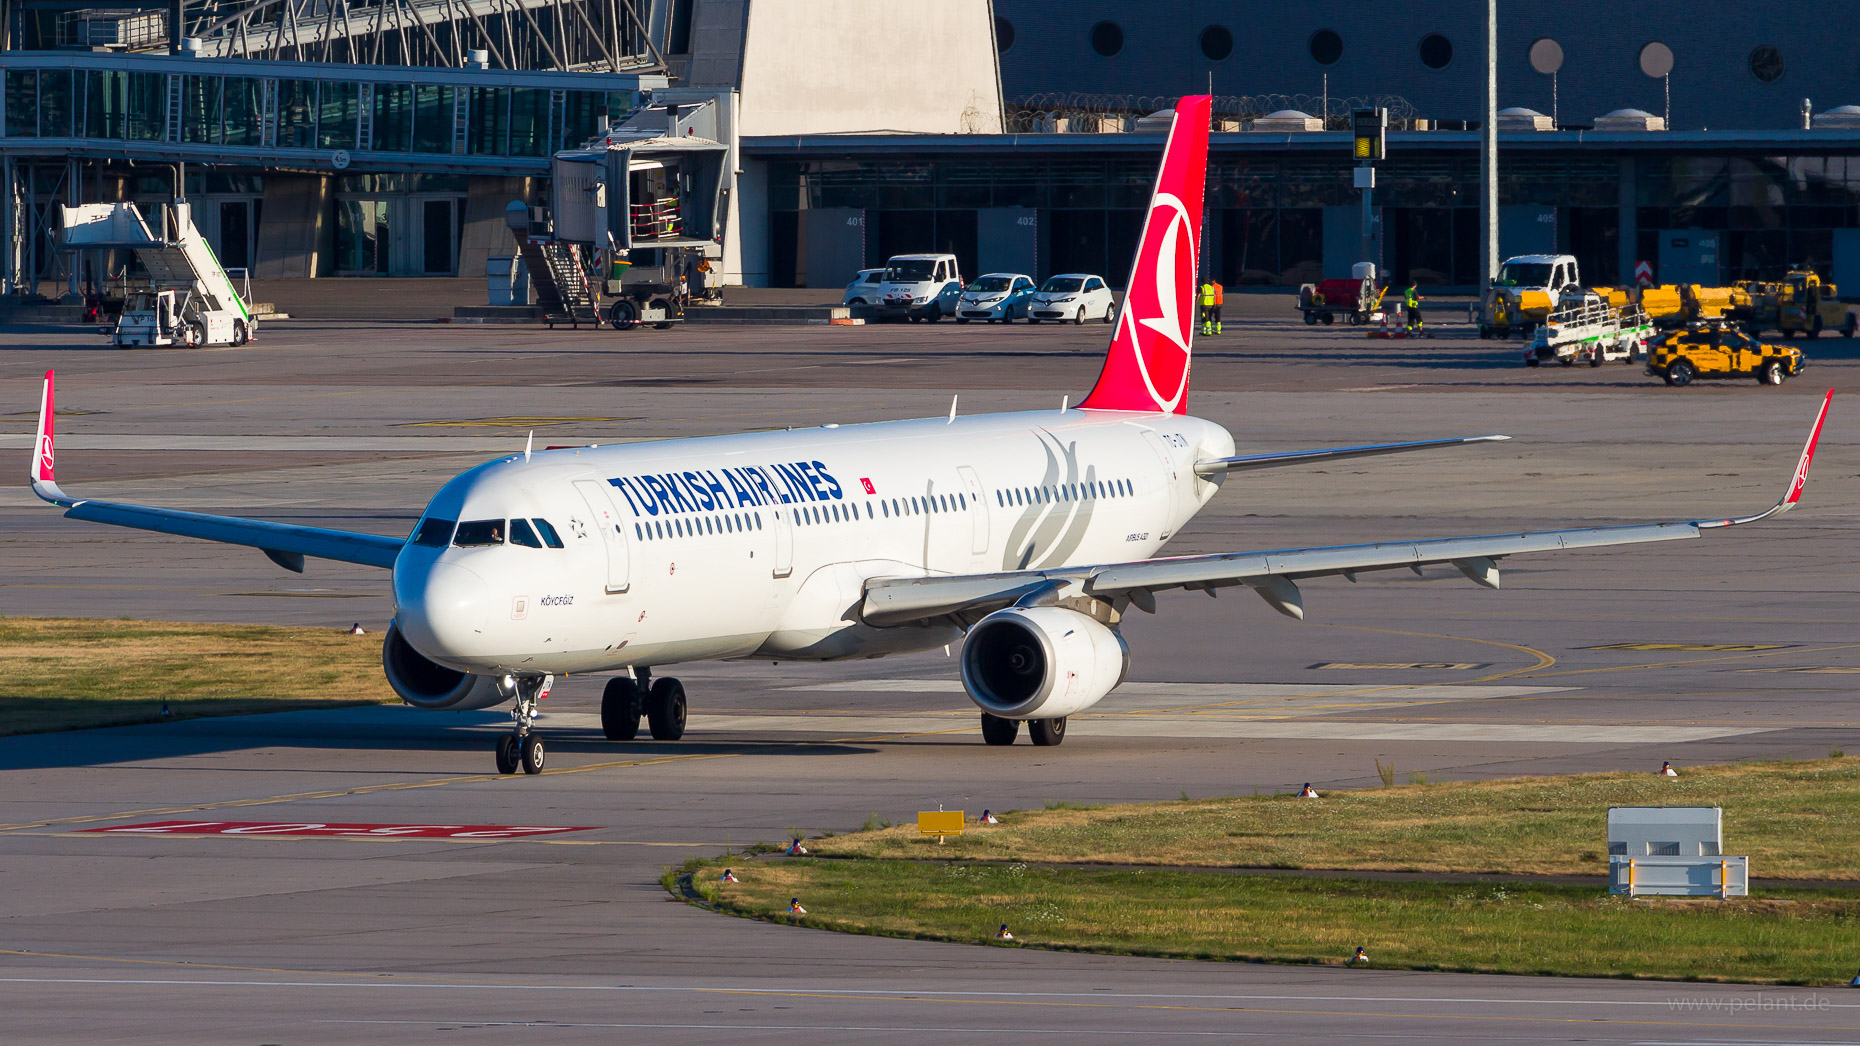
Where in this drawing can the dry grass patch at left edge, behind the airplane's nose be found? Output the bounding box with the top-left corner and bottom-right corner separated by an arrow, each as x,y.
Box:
0,618 -> 396,735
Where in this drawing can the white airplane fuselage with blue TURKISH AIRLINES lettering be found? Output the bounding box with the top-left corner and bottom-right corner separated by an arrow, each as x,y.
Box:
394,409 -> 1233,674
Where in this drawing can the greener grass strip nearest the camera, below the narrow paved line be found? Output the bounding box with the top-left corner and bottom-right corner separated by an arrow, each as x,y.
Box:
666,854 -> 1860,985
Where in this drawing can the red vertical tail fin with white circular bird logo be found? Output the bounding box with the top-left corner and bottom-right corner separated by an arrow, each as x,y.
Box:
1079,95 -> 1215,413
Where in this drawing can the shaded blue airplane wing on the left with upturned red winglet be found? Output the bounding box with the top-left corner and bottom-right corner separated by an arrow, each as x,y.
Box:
30,370 -> 405,573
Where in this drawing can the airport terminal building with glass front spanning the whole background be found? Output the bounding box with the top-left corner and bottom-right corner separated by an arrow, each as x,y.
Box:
0,0 -> 1860,294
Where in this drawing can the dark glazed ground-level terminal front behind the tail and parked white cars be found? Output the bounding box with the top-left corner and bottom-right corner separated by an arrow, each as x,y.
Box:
768,145 -> 1860,287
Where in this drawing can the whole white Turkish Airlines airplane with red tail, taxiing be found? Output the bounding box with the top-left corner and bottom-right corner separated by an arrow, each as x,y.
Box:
32,97 -> 1832,772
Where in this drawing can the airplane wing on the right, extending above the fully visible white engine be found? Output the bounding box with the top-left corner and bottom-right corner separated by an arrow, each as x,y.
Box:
861,389 -> 1834,625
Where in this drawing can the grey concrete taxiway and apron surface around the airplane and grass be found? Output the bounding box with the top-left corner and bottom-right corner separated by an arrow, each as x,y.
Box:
0,312 -> 1860,1042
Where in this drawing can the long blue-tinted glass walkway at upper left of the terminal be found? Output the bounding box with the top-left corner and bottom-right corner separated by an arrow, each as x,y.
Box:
0,65 -> 640,158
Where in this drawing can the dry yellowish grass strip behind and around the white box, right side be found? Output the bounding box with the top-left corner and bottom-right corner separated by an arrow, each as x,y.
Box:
807,758 -> 1860,878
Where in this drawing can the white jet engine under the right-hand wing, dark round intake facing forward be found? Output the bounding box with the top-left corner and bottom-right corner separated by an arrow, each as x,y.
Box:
962,607 -> 1131,718
